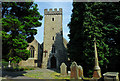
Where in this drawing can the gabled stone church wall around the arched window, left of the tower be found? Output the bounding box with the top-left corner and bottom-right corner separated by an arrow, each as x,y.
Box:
19,39 -> 42,67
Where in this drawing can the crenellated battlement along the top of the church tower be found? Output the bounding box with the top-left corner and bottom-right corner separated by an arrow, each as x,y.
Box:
44,8 -> 62,15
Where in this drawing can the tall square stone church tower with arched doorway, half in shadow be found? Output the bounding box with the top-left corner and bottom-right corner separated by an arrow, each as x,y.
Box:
42,8 -> 67,69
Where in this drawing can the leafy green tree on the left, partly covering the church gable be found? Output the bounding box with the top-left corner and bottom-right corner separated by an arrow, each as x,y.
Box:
2,2 -> 42,63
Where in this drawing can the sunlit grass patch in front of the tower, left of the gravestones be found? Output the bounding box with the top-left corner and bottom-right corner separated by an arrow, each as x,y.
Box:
23,69 -> 70,79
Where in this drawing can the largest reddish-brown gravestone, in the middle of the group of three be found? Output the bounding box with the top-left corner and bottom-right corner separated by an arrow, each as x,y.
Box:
70,62 -> 79,79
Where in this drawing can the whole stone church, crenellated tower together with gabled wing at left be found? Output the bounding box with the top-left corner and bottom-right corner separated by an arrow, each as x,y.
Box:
19,8 -> 67,69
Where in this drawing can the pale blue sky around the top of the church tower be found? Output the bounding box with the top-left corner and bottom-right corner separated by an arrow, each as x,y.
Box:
35,0 -> 73,43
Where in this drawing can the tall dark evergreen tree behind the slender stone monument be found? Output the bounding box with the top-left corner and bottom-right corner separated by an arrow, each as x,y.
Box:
68,2 -> 120,75
